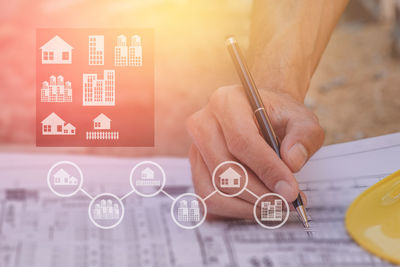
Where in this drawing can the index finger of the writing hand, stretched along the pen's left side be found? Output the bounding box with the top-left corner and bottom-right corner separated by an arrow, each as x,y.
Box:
210,87 -> 299,201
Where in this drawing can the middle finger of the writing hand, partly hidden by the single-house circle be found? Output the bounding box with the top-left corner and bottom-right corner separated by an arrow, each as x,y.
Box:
188,109 -> 270,203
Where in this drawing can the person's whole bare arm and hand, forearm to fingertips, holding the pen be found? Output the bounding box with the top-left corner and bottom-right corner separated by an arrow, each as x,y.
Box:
187,0 -> 347,218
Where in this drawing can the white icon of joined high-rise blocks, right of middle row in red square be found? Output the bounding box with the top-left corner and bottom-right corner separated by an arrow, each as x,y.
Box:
83,70 -> 115,106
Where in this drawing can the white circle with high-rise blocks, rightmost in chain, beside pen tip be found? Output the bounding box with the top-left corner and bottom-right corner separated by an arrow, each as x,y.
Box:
253,193 -> 289,229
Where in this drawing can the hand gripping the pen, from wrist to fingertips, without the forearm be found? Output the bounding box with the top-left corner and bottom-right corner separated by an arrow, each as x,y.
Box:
187,86 -> 324,219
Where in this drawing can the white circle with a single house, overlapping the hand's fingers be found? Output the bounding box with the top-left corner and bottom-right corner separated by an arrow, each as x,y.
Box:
212,161 -> 249,197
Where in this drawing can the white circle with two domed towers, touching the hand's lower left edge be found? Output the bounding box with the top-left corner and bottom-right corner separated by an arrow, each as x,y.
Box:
171,193 -> 207,229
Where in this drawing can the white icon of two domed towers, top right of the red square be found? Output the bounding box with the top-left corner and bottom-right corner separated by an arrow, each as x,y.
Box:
114,34 -> 142,67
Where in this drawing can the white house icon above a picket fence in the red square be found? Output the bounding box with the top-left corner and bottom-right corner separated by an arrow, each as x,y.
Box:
86,113 -> 119,140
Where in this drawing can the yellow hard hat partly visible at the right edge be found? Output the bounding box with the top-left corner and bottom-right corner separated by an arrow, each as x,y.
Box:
345,170 -> 400,264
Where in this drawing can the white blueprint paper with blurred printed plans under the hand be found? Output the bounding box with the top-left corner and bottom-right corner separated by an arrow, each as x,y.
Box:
0,134 -> 400,267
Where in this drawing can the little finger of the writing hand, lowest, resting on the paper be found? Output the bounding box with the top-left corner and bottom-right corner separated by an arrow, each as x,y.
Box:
189,146 -> 253,219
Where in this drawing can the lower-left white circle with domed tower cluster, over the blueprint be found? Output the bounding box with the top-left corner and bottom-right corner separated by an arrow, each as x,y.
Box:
88,193 -> 125,229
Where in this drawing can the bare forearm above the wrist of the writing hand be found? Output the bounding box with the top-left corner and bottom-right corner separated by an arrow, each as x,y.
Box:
249,0 -> 348,101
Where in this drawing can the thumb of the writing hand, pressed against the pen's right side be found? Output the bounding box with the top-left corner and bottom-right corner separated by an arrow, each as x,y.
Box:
281,117 -> 325,172
